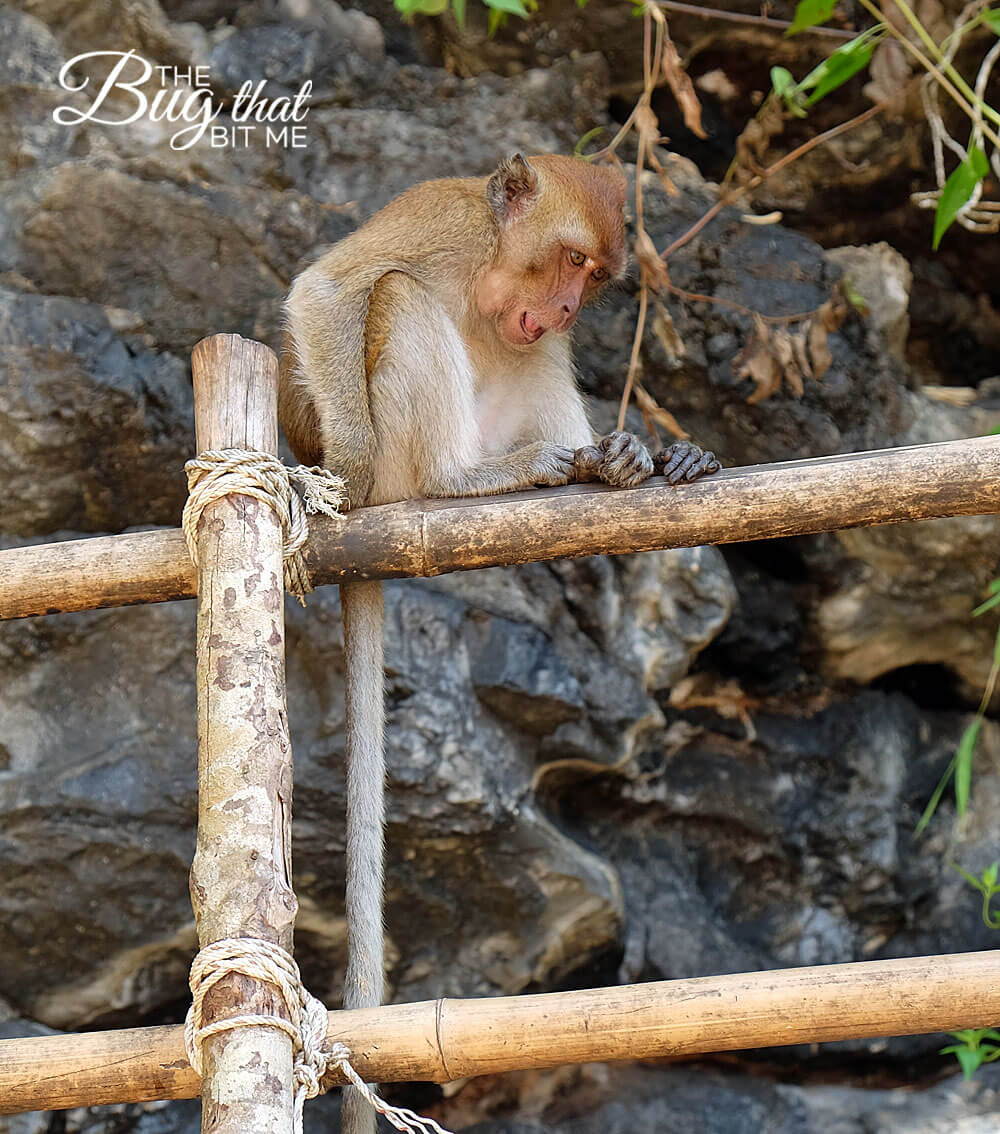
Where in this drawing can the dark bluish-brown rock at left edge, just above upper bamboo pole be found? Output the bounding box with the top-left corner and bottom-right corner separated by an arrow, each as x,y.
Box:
0,288 -> 194,535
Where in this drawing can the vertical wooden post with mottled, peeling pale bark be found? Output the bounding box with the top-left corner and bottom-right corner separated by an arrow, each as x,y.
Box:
190,335 -> 297,1134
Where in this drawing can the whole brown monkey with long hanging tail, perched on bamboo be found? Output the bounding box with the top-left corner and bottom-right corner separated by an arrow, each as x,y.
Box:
279,154 -> 719,1134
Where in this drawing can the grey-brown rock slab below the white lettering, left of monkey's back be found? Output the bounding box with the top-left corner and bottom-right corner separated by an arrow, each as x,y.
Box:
0,163 -> 346,353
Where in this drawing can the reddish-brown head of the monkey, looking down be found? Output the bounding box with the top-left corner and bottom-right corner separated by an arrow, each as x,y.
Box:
475,153 -> 625,347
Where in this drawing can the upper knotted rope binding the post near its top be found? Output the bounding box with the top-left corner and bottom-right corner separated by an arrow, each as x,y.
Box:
180,449 -> 345,606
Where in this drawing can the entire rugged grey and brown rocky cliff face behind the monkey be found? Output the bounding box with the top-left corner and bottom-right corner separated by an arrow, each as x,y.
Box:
0,0 -> 1000,1134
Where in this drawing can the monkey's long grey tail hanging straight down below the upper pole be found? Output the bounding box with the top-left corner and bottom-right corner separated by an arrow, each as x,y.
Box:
340,583 -> 385,1134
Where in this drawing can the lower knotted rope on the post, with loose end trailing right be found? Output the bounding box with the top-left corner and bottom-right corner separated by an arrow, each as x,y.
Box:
184,937 -> 449,1134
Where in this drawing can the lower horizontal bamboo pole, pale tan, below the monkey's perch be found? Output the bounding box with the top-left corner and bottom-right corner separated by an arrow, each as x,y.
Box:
0,950 -> 1000,1114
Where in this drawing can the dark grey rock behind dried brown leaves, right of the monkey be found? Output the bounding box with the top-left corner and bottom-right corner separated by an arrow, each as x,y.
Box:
577,155 -> 910,465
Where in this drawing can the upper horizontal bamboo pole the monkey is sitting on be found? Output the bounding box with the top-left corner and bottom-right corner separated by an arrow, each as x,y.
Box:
0,437 -> 1000,618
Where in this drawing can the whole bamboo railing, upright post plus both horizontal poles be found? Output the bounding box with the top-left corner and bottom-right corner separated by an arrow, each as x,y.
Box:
0,336 -> 1000,1134
